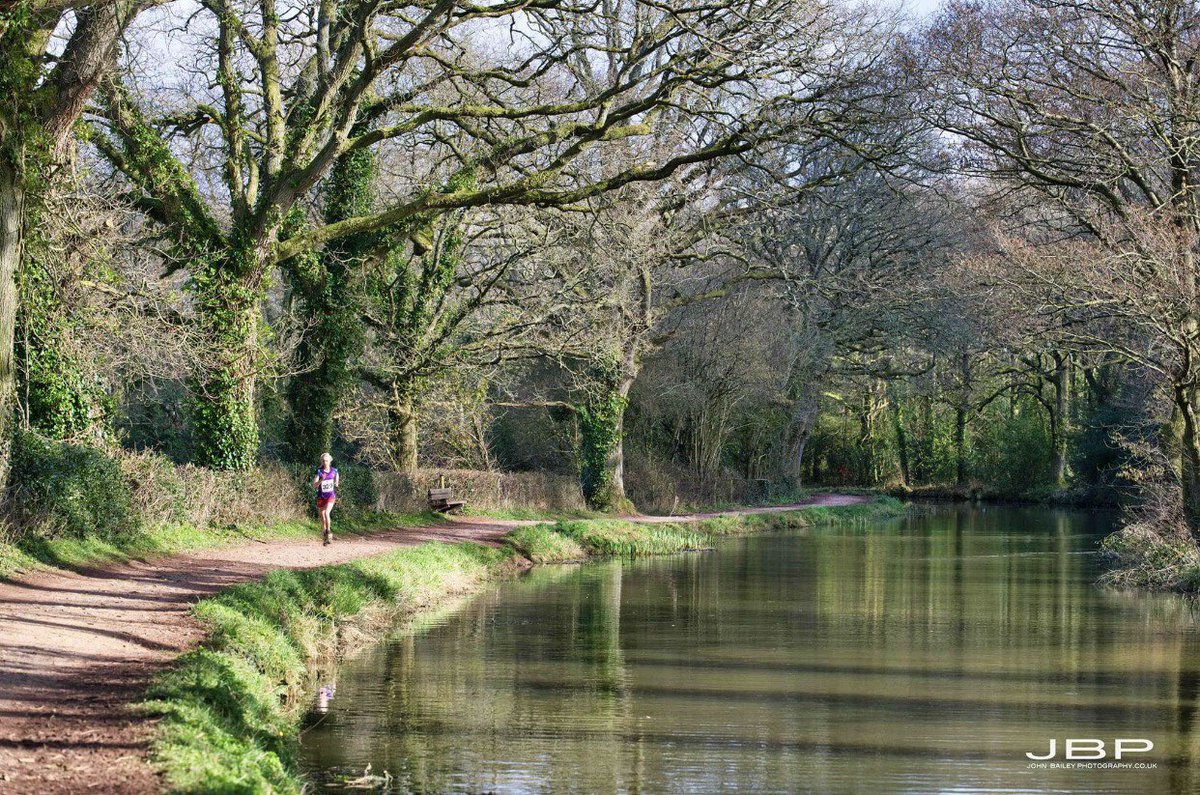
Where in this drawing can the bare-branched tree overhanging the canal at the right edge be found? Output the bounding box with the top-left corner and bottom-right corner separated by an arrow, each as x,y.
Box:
916,0 -> 1200,538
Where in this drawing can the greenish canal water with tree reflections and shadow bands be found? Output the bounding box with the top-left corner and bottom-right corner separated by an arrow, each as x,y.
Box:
302,508 -> 1200,794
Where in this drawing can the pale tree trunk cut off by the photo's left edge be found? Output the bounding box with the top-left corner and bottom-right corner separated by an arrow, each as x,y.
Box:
0,149 -> 25,483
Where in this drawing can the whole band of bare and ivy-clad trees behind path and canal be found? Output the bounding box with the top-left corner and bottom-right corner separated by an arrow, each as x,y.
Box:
0,0 -> 1200,585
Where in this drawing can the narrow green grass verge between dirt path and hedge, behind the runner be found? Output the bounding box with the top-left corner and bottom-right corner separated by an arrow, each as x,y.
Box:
0,513 -> 445,579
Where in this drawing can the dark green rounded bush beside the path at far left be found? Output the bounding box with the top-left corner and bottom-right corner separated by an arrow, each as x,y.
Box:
8,432 -> 140,537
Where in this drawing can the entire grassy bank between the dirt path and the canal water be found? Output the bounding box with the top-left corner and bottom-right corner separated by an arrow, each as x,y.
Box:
144,497 -> 904,794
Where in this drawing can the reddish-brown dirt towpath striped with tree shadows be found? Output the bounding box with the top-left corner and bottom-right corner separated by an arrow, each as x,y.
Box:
0,495 -> 866,794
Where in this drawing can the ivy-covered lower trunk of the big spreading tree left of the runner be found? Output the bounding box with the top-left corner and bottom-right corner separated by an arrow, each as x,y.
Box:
192,246 -> 264,470
